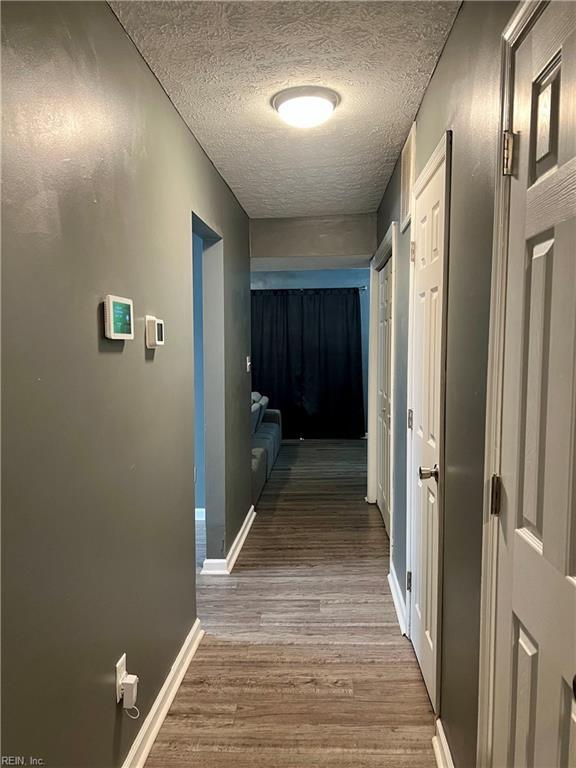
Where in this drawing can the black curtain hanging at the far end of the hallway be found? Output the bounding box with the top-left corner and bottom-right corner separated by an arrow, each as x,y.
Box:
252,288 -> 364,438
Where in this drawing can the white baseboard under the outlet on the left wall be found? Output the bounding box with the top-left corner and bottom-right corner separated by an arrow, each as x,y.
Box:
122,619 -> 204,768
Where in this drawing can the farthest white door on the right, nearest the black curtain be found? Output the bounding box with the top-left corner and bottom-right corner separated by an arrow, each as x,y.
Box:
377,258 -> 392,534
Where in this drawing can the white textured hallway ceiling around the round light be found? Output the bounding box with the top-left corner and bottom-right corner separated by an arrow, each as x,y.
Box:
111,0 -> 459,218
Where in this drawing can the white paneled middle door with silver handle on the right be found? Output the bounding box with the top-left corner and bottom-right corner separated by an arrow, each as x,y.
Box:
408,134 -> 449,710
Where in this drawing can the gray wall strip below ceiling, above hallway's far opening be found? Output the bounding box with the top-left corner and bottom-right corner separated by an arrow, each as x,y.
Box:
250,213 -> 376,270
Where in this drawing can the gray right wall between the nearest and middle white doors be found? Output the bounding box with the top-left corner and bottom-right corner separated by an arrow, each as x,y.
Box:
378,2 -> 516,768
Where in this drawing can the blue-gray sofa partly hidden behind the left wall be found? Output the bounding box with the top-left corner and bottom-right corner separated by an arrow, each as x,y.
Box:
251,392 -> 282,504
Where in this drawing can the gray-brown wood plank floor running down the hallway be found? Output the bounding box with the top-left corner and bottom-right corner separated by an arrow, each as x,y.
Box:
147,441 -> 435,768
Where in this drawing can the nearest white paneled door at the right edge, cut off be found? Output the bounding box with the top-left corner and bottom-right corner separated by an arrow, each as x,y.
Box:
493,3 -> 576,768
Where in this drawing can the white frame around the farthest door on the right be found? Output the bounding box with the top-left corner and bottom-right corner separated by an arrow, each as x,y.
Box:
366,221 -> 398,540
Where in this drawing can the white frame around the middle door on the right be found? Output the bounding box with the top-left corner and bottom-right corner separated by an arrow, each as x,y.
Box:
406,130 -> 452,713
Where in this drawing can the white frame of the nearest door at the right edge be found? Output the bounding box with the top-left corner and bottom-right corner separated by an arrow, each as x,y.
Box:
476,0 -> 548,768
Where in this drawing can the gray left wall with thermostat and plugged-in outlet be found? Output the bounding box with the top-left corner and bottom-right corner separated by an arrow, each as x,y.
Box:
2,2 -> 250,768
